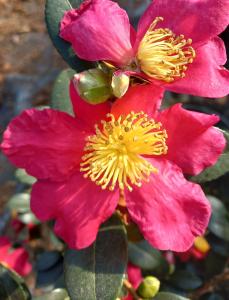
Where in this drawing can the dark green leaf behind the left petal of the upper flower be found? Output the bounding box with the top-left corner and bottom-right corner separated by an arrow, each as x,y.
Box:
45,0 -> 94,72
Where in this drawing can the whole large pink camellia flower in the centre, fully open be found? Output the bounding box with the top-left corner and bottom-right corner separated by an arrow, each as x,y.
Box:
1,84 -> 225,251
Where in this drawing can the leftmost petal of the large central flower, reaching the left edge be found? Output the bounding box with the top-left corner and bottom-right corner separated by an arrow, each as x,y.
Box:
1,109 -> 90,181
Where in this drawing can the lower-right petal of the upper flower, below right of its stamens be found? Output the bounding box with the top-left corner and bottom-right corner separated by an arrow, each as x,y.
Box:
164,37 -> 229,98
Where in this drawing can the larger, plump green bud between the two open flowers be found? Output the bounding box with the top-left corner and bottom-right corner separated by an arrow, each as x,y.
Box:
73,69 -> 112,104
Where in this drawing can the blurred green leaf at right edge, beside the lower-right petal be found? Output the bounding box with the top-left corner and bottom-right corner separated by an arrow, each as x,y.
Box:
207,196 -> 229,241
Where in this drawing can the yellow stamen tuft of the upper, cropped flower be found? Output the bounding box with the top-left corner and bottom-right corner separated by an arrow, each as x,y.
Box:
137,17 -> 195,82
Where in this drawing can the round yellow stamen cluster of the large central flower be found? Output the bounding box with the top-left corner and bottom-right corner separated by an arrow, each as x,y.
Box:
80,112 -> 167,191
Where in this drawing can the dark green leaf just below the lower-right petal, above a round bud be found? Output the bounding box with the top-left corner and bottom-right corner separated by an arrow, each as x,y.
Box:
128,240 -> 169,275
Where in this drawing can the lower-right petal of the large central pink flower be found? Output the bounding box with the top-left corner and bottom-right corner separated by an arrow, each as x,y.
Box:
126,159 -> 211,252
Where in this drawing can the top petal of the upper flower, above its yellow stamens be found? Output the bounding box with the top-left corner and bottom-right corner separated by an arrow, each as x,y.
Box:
137,0 -> 229,47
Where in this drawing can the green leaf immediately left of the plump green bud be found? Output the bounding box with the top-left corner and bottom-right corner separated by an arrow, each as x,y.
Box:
51,69 -> 75,116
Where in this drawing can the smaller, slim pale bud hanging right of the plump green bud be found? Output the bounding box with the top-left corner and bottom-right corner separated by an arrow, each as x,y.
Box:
111,72 -> 130,98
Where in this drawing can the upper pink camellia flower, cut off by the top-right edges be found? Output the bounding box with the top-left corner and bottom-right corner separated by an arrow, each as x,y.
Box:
60,0 -> 229,97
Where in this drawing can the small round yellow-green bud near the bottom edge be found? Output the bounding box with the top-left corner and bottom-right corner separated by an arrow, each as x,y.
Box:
137,276 -> 160,298
